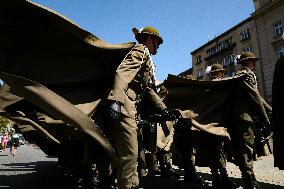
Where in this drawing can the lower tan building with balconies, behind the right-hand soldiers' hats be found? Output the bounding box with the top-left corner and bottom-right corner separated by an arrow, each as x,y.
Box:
190,17 -> 262,91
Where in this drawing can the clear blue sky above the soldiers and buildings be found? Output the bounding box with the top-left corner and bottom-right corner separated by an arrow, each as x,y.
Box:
32,0 -> 254,81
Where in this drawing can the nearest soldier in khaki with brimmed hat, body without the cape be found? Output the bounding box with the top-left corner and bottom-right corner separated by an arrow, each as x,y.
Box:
105,27 -> 180,189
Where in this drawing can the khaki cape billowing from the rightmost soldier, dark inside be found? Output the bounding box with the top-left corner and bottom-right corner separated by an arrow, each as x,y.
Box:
163,75 -> 272,152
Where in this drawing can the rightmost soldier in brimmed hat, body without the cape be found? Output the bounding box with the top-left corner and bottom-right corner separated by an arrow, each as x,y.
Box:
229,52 -> 261,189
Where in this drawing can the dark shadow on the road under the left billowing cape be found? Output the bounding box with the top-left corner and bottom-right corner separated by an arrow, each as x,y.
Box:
0,161 -> 77,189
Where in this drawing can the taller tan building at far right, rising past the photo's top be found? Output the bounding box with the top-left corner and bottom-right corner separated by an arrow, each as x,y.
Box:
252,0 -> 284,103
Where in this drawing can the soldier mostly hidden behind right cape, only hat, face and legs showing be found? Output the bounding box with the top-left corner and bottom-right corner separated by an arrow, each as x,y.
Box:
208,64 -> 236,189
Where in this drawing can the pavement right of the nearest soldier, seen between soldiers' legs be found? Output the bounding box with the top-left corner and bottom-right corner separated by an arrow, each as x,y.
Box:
142,155 -> 284,189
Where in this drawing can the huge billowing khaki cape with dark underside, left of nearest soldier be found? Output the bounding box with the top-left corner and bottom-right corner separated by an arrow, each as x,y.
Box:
0,0 -> 135,165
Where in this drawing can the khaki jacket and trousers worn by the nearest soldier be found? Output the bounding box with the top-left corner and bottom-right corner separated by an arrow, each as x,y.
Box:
108,44 -> 166,189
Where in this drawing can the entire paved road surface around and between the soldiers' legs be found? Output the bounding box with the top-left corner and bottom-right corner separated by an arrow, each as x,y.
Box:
0,145 -> 284,189
